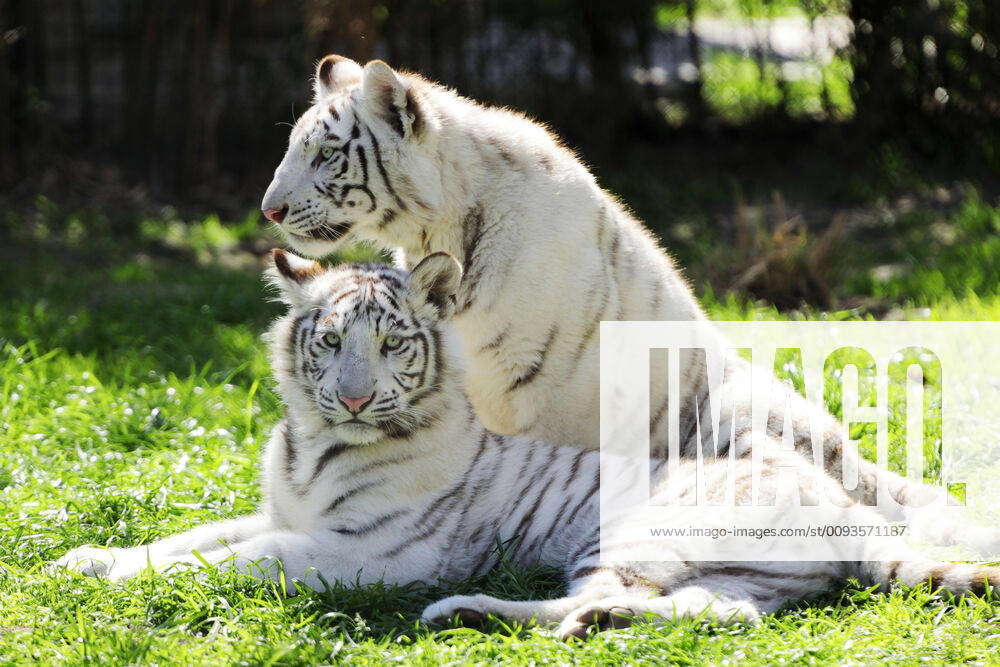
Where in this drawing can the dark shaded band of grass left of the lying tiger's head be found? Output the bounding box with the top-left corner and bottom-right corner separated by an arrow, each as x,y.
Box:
0,244 -> 281,383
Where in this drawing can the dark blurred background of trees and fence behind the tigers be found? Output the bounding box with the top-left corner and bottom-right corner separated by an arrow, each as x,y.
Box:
0,0 -> 1000,312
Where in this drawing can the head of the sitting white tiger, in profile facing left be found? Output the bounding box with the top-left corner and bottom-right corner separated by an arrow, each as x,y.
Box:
261,55 -> 441,257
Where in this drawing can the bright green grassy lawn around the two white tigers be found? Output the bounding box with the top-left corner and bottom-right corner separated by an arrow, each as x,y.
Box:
0,206 -> 1000,664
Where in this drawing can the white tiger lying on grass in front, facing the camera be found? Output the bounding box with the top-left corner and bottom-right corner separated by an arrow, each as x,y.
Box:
59,251 -> 1000,637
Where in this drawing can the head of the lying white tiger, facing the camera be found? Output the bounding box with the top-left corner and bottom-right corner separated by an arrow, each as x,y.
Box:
270,250 -> 462,445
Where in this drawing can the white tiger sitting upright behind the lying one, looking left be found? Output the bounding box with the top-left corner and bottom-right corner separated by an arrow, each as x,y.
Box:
262,56 -> 1000,554
